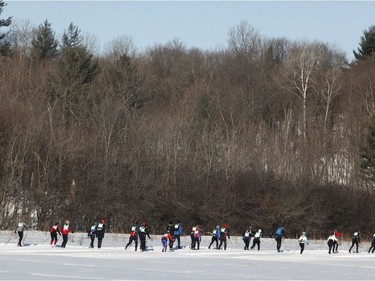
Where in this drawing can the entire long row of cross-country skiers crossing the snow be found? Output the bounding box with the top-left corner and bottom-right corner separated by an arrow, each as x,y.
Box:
15,219 -> 375,254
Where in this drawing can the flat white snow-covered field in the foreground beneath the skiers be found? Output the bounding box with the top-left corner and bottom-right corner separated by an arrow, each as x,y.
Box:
0,231 -> 375,280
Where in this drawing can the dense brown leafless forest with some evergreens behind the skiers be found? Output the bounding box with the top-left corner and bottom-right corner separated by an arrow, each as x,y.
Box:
0,0 -> 375,238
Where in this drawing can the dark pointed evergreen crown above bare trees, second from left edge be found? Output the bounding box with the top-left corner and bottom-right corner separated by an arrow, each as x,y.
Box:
31,20 -> 58,59
